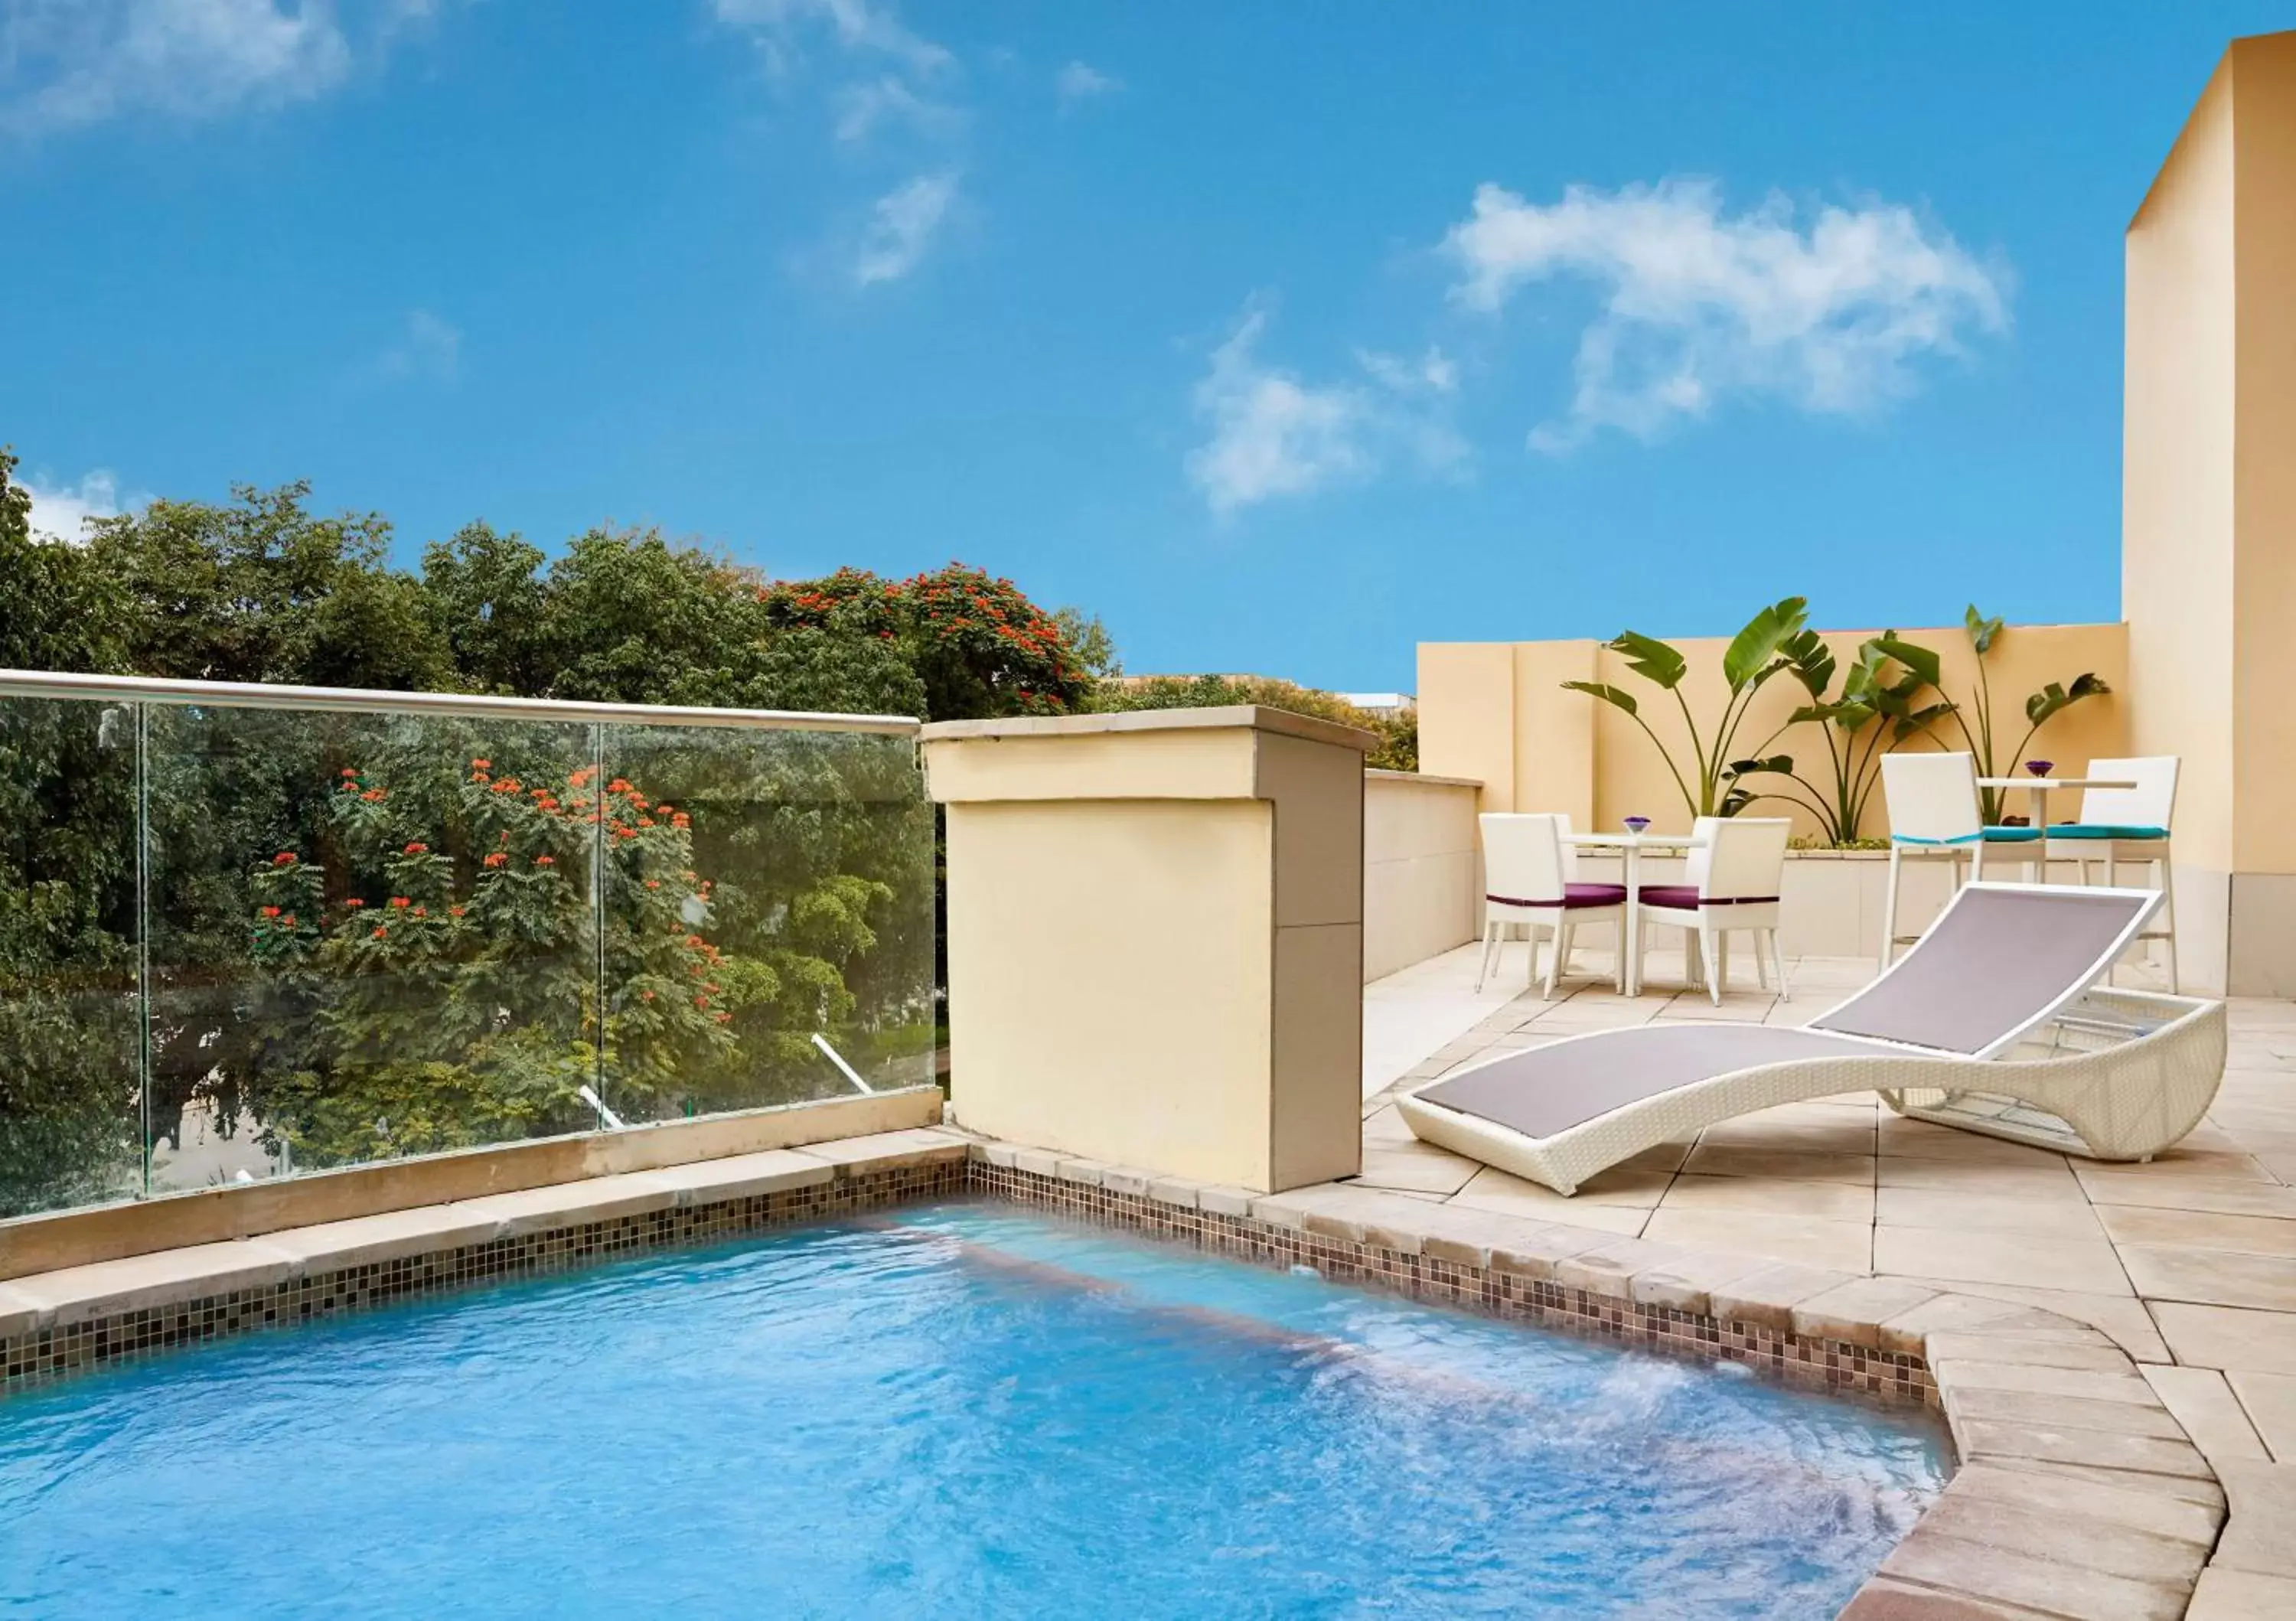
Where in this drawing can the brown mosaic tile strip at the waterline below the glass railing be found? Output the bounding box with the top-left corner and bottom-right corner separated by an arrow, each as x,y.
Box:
0,1159 -> 967,1396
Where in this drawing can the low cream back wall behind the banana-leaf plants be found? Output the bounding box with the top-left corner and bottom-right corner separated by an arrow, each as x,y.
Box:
1419,620 -> 2131,836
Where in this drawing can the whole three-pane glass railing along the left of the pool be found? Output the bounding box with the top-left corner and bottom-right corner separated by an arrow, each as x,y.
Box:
0,675 -> 934,1215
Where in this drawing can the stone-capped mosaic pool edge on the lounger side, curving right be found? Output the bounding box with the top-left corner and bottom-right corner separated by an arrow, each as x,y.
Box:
971,1141 -> 2241,1621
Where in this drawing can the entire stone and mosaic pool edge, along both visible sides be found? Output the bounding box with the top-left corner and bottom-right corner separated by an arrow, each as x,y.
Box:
0,1130 -> 2241,1621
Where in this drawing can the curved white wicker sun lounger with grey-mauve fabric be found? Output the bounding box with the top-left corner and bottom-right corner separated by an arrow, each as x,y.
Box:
1398,884 -> 2225,1194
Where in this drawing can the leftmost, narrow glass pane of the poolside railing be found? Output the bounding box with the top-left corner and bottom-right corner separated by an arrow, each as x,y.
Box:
0,698 -> 142,1217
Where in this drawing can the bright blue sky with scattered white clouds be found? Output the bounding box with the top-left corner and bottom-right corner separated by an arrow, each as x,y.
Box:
0,0 -> 2287,689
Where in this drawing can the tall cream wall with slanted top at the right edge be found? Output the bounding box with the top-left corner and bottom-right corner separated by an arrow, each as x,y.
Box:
2122,34 -> 2296,994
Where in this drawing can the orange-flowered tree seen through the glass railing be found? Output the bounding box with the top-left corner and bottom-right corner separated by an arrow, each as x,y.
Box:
243,739 -> 914,1166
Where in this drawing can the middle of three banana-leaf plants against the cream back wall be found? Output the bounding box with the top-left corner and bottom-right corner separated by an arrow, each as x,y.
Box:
1729,631 -> 1954,845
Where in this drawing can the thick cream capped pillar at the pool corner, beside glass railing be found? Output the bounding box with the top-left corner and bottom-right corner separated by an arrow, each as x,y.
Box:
925,705 -> 1373,1192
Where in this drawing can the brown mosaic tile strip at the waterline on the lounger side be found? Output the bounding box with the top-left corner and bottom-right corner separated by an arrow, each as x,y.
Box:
969,1159 -> 1938,1407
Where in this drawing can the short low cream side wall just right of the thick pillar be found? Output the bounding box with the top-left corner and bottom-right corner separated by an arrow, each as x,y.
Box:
1364,771 -> 1481,985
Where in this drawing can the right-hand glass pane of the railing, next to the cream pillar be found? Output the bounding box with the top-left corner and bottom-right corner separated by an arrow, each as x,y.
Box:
602,726 -> 934,1120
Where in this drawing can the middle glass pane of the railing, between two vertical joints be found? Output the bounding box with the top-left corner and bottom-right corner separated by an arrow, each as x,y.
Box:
145,703 -> 599,1192
